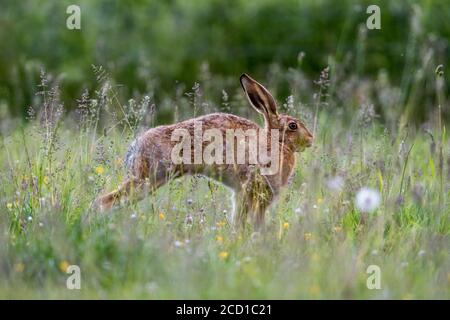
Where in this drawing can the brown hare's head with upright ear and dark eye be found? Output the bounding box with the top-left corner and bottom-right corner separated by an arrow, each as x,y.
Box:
240,73 -> 313,152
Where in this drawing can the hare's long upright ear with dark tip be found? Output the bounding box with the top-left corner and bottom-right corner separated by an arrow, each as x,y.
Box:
240,73 -> 278,125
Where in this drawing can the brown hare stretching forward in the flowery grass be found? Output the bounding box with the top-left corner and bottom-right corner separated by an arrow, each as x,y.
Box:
95,74 -> 313,229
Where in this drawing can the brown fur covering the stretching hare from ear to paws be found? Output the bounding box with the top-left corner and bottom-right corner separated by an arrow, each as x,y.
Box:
95,74 -> 313,227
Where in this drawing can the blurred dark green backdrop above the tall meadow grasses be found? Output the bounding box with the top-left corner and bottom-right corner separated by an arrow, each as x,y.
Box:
0,0 -> 450,123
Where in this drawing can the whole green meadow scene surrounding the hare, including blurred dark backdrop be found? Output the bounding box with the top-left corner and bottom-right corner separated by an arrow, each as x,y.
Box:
0,0 -> 450,299
